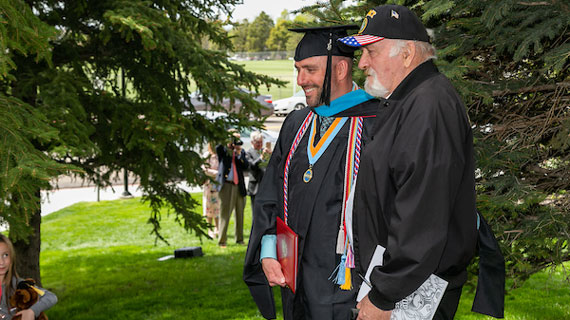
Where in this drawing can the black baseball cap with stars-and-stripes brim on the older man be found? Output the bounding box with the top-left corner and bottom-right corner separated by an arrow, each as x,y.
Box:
339,5 -> 430,48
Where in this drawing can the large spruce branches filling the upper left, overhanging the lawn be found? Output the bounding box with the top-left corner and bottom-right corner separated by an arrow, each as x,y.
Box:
0,0 -> 278,248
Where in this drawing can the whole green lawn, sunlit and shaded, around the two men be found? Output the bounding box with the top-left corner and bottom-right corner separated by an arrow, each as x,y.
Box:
37,194 -> 570,320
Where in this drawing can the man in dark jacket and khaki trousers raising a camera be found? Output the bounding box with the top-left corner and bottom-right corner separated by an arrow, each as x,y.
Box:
216,132 -> 249,248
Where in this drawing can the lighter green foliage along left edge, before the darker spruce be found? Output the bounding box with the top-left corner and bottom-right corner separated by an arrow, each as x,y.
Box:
0,1 -> 73,240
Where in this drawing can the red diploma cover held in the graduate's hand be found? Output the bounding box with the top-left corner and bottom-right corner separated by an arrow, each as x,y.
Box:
277,217 -> 299,293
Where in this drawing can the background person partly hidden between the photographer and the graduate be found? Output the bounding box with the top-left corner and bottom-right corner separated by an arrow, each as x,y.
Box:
245,131 -> 271,213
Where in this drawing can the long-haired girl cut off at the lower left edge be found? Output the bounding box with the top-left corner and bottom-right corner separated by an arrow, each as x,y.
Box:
0,234 -> 57,320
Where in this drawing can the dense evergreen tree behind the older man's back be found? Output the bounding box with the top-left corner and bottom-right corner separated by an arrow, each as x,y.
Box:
423,1 -> 570,286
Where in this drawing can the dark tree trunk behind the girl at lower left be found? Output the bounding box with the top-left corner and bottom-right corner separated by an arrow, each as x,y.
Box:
14,204 -> 42,286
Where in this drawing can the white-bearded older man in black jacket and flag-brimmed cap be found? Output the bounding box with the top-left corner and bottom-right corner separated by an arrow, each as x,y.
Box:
340,5 -> 477,320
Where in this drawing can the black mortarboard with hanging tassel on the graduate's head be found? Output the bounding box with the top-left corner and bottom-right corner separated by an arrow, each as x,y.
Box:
289,25 -> 358,105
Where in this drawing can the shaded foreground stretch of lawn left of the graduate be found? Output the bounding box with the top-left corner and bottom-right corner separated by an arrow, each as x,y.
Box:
42,246 -> 280,319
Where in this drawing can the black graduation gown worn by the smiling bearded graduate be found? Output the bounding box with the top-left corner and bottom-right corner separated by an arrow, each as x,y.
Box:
244,100 -> 378,319
